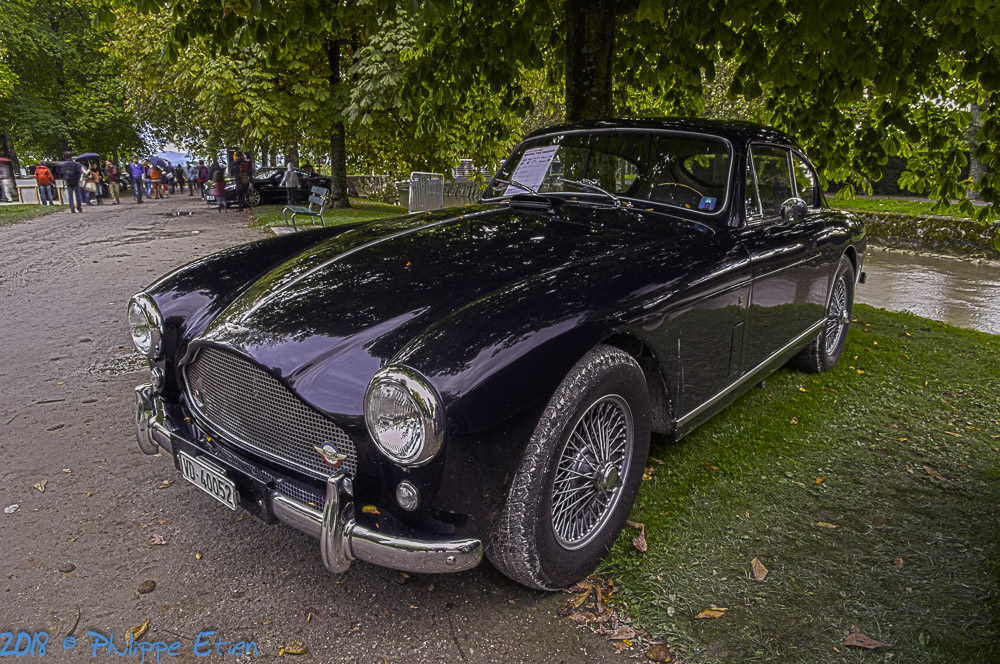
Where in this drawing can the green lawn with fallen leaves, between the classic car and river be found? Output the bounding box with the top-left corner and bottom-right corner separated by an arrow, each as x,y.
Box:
601,305 -> 1000,664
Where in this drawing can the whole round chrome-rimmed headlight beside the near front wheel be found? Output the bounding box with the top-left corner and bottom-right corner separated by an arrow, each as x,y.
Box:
365,366 -> 444,466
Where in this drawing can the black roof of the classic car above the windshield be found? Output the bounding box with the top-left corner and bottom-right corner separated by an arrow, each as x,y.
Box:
527,117 -> 801,150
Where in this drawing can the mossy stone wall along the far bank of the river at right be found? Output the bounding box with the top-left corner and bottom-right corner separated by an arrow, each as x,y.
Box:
853,212 -> 1000,260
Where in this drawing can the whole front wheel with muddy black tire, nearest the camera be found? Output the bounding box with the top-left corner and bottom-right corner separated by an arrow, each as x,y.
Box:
486,345 -> 650,590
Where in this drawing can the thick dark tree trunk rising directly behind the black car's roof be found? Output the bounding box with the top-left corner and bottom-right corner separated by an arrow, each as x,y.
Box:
566,0 -> 616,122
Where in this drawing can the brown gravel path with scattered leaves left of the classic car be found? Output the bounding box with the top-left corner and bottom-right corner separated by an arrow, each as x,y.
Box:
0,196 -> 622,662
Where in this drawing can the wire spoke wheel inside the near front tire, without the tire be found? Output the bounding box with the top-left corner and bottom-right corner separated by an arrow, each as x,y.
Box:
552,395 -> 635,550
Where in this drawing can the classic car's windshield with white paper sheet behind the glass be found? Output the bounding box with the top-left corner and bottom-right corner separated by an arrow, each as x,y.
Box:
483,131 -> 731,214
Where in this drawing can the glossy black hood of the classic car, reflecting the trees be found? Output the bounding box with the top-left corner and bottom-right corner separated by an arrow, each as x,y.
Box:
188,205 -> 712,416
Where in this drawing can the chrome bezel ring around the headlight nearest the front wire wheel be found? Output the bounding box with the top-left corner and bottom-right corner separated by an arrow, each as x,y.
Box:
364,365 -> 445,467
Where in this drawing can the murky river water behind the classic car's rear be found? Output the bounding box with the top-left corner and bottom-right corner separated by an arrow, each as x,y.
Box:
855,249 -> 1000,334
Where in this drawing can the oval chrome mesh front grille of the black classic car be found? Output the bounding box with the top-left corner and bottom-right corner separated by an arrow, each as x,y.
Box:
184,348 -> 358,478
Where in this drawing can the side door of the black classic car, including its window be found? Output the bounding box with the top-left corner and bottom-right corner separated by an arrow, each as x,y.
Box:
740,144 -> 830,370
